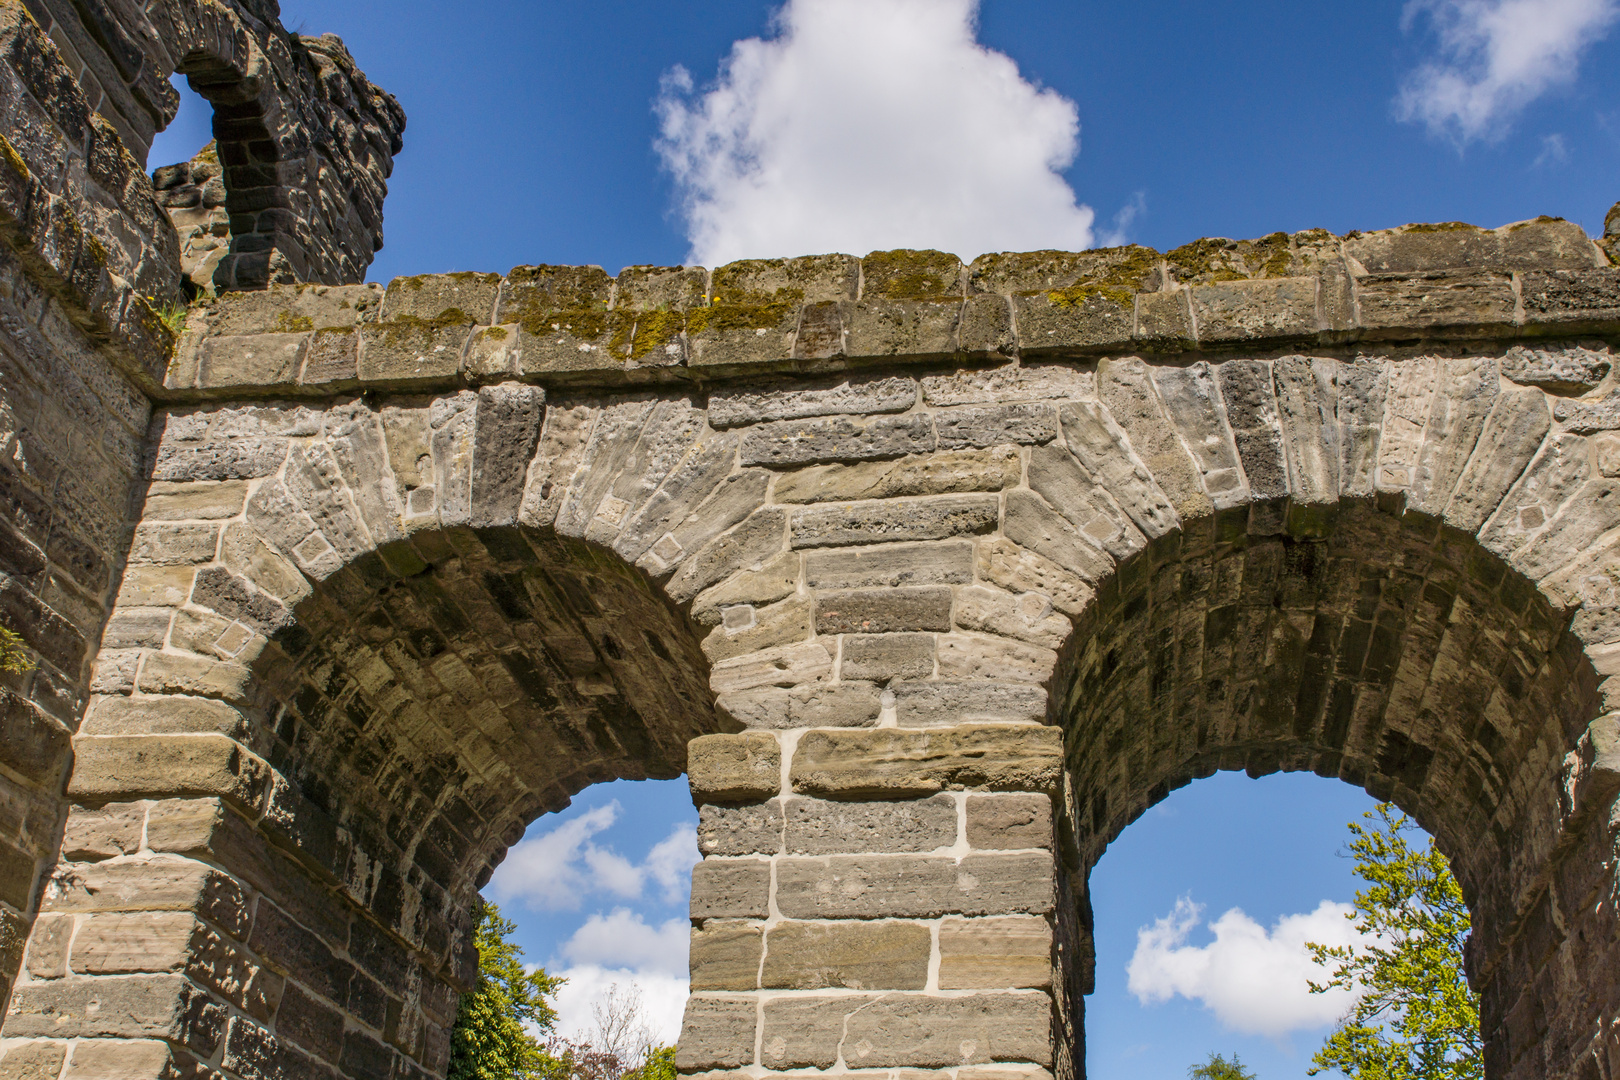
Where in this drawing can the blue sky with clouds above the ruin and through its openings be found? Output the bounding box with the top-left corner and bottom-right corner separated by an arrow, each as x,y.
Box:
142,0 -> 1620,1080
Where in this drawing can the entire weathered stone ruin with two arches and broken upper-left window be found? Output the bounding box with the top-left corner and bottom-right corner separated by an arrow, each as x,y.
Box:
0,0 -> 1620,1080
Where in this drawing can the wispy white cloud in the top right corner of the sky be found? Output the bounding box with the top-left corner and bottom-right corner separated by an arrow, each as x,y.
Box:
1396,0 -> 1620,142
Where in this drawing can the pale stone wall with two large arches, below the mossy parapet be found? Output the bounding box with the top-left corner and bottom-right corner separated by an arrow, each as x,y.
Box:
6,344 -> 1620,1080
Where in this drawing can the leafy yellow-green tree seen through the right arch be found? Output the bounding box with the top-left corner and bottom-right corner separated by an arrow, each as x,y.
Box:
1307,803 -> 1484,1080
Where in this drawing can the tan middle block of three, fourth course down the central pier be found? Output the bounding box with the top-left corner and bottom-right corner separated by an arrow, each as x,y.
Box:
757,920 -> 933,989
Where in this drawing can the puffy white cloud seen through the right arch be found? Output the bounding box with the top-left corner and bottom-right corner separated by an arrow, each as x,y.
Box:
1126,897 -> 1359,1038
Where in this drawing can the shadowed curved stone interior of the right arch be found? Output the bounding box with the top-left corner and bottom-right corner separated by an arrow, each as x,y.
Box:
1055,502 -> 1612,1075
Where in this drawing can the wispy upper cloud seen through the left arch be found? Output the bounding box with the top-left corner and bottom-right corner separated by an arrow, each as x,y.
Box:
489,801 -> 698,912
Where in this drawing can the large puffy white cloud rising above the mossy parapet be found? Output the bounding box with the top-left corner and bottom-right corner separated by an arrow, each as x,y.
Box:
656,0 -> 1094,266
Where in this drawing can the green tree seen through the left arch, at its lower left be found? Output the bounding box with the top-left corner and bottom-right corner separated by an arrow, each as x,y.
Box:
447,904 -> 564,1080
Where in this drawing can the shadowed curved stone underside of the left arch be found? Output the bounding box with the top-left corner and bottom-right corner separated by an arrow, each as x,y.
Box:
238,528 -> 721,977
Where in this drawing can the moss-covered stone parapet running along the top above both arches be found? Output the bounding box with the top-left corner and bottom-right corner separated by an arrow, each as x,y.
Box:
165,207 -> 1620,400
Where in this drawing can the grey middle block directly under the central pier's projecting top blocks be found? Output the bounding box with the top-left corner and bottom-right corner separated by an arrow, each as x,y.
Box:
787,795 -> 956,854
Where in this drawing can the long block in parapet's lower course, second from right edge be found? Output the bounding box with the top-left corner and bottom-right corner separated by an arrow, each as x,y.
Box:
1356,270 -> 1516,338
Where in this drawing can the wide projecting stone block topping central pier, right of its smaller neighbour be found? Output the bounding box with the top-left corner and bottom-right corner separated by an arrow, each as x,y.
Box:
791,724 -> 1063,800
